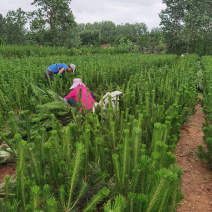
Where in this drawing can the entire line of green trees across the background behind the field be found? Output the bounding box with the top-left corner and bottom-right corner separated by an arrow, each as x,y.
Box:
0,0 -> 212,55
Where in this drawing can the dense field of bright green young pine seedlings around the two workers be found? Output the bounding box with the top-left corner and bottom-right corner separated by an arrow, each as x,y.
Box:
0,50 -> 212,212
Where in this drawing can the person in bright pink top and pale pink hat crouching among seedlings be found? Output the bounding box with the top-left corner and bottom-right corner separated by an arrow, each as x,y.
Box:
64,78 -> 96,111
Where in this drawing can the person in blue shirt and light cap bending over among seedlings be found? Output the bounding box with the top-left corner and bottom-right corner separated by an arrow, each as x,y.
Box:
44,63 -> 76,81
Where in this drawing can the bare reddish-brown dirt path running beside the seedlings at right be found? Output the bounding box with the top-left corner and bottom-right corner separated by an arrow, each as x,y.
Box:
175,105 -> 212,212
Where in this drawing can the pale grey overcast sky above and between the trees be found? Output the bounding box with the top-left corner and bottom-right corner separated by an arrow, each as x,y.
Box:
0,0 -> 166,30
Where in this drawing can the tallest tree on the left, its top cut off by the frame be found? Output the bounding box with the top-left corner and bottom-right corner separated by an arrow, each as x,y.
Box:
32,0 -> 79,47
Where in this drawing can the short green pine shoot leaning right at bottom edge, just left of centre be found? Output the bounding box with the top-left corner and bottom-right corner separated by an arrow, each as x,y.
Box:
82,187 -> 110,212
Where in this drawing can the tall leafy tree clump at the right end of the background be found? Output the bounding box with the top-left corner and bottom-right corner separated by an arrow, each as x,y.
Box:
159,0 -> 212,55
